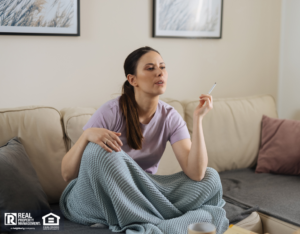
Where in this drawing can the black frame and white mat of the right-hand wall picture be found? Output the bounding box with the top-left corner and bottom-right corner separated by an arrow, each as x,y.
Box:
152,0 -> 224,39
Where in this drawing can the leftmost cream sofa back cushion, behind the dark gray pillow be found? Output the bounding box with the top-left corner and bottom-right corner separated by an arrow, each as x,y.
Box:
0,106 -> 68,203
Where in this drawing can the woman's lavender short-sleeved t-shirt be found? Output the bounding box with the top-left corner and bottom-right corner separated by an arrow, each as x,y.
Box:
83,96 -> 190,174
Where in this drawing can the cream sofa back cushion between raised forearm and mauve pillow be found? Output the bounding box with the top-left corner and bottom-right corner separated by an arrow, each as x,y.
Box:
184,95 -> 277,172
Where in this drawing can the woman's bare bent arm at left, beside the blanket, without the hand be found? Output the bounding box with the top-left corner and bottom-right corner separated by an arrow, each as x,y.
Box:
61,129 -> 89,182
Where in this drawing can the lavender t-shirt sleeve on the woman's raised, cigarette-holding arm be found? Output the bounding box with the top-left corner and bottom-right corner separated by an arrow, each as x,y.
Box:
168,109 -> 191,145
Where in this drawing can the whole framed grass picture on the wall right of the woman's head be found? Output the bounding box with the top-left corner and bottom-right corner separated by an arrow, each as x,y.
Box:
152,0 -> 223,39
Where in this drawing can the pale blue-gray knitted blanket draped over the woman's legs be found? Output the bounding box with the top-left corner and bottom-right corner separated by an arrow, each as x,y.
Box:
59,142 -> 229,234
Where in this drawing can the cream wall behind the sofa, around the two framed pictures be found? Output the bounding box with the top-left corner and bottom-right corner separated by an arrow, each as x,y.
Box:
0,0 -> 282,110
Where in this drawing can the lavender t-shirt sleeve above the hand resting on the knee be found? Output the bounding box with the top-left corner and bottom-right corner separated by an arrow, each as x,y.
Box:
82,102 -> 116,131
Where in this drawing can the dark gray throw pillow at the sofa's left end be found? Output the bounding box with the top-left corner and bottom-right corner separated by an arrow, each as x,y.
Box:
0,137 -> 51,225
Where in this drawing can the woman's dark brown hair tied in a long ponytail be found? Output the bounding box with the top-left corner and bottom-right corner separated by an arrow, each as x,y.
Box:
119,46 -> 159,150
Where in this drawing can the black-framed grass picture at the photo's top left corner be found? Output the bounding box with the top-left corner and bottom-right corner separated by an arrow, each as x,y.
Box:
0,0 -> 80,36
